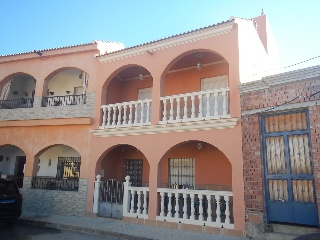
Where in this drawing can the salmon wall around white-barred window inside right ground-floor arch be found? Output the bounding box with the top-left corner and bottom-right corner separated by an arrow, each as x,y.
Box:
161,142 -> 232,188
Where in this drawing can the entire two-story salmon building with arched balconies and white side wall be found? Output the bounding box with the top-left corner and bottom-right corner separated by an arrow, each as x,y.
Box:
0,12 -> 277,236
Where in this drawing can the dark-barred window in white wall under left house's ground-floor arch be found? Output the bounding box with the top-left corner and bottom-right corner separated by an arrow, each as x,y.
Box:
56,157 -> 81,178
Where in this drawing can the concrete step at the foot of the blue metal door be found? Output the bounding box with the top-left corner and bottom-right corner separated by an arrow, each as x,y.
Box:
270,224 -> 320,236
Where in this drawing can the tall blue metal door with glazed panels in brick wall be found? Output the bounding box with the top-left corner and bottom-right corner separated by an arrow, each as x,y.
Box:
262,111 -> 319,226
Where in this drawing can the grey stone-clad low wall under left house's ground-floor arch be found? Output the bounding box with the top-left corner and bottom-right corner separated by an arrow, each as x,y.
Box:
21,177 -> 88,216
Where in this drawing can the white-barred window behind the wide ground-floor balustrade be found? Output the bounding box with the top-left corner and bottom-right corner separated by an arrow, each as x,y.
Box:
169,158 -> 195,189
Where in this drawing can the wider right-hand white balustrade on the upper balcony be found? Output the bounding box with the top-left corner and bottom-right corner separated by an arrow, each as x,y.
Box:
160,88 -> 230,124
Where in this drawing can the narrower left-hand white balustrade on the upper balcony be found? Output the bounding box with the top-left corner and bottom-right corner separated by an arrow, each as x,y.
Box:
100,99 -> 152,129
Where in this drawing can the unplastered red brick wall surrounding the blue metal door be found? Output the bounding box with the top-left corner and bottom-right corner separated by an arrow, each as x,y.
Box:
241,80 -> 320,235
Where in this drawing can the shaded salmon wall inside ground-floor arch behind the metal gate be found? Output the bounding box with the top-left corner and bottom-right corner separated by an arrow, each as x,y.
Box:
101,145 -> 150,183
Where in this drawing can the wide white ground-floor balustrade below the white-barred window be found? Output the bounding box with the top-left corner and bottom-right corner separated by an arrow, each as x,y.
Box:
157,188 -> 234,229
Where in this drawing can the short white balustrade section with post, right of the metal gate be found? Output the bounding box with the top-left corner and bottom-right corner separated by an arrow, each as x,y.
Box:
123,176 -> 149,218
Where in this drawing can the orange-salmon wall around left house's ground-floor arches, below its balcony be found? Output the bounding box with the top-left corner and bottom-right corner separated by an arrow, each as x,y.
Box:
0,124 -> 91,178
